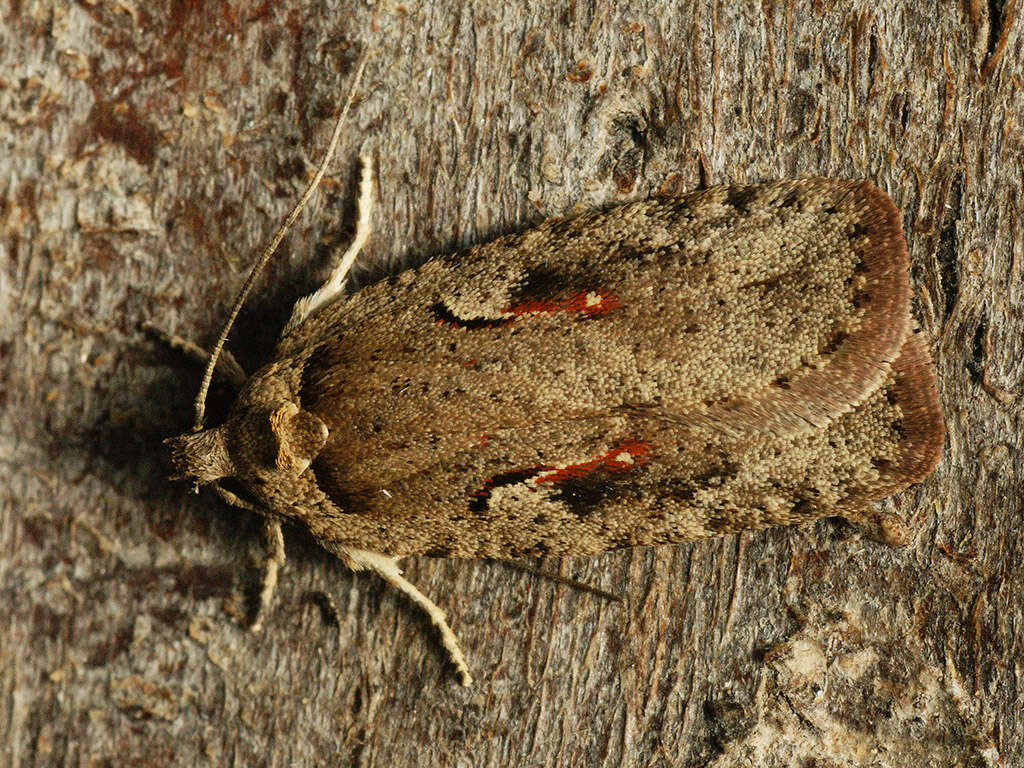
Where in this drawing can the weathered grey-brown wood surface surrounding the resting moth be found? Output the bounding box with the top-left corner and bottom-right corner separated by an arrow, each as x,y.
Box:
0,0 -> 1024,767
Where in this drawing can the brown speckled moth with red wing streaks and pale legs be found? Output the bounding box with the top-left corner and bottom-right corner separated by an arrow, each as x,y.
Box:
157,63 -> 944,685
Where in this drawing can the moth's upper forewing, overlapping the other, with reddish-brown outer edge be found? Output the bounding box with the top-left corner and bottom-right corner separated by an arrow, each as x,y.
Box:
286,179 -> 910,431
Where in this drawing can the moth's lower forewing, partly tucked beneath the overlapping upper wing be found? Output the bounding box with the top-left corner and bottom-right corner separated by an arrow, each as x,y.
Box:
299,335 -> 944,557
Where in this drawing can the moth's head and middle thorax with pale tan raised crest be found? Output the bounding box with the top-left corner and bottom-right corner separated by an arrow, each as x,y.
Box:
164,401 -> 328,485
